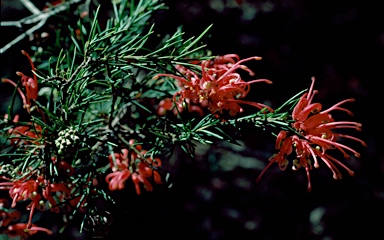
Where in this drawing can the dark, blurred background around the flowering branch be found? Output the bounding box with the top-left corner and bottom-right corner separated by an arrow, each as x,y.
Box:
0,0 -> 384,240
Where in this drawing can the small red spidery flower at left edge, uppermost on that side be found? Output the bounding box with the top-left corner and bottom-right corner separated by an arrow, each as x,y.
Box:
2,50 -> 39,112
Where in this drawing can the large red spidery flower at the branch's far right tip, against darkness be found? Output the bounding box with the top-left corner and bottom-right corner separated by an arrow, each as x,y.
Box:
257,78 -> 366,191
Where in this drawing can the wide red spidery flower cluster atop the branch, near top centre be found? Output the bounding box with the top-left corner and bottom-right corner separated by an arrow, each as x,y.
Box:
155,54 -> 273,116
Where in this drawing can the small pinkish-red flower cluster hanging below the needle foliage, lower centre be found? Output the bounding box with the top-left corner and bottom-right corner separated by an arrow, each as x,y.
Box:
105,140 -> 162,194
